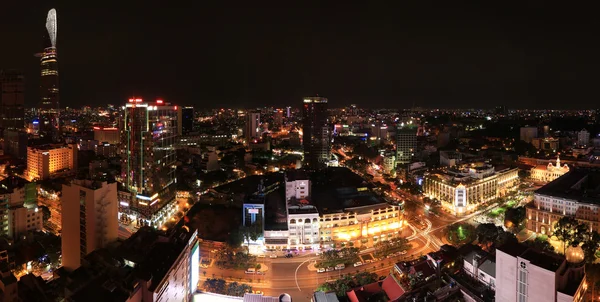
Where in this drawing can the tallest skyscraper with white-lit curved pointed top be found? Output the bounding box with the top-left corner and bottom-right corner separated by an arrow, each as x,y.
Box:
38,9 -> 60,138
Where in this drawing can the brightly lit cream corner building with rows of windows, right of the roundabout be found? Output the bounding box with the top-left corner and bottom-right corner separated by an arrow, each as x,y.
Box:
423,164 -> 519,215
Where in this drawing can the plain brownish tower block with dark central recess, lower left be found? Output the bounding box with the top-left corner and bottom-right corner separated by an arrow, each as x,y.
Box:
61,179 -> 119,271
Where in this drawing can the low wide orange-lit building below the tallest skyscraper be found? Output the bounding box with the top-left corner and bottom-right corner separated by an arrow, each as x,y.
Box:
26,144 -> 78,180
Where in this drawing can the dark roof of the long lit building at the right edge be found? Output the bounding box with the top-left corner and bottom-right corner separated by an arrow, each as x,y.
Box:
535,169 -> 600,203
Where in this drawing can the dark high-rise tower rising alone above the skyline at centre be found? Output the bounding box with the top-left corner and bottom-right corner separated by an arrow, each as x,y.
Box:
302,96 -> 331,169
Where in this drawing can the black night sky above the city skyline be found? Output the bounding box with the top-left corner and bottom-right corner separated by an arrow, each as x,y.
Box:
0,0 -> 600,108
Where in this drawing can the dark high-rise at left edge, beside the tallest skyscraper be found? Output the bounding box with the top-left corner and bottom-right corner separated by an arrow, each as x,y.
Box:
0,70 -> 25,135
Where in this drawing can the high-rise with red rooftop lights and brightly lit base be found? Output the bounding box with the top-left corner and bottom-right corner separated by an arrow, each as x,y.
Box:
120,99 -> 179,227
